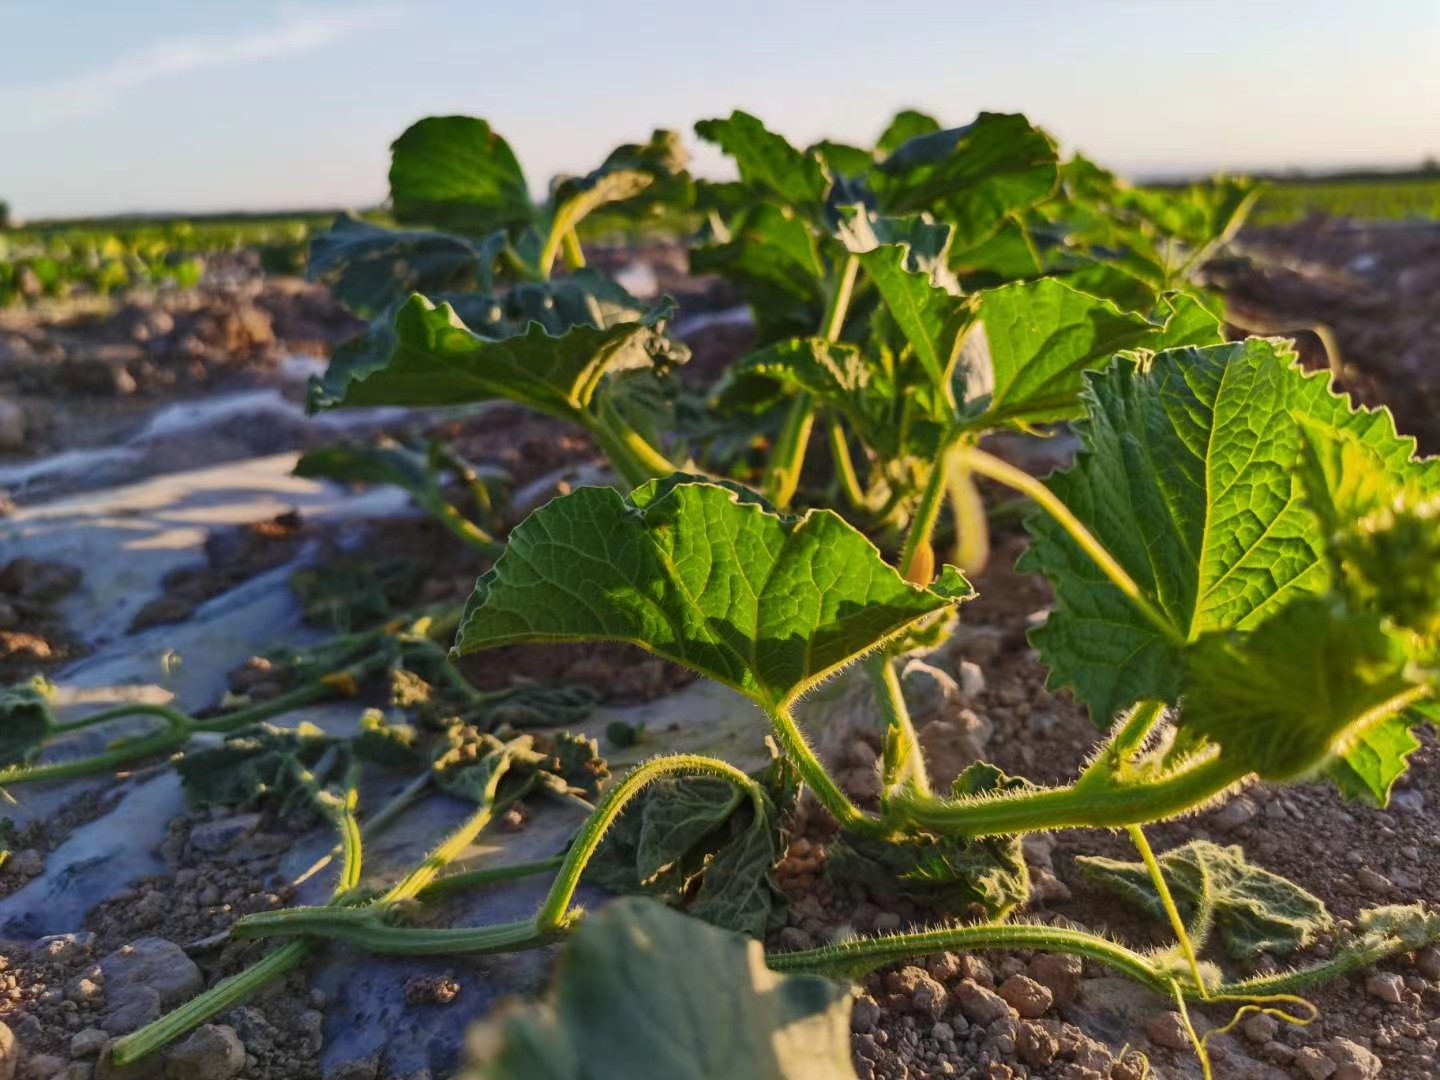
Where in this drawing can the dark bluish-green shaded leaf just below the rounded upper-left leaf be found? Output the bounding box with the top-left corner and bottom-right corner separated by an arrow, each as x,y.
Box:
307,215 -> 494,318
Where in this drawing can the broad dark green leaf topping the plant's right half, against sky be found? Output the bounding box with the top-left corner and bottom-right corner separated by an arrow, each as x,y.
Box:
873,112 -> 1058,253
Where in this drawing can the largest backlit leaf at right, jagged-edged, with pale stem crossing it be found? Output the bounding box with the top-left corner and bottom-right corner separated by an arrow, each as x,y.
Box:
1020,338 -> 1392,726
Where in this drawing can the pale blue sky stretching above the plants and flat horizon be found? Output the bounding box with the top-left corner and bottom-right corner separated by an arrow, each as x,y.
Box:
0,0 -> 1440,217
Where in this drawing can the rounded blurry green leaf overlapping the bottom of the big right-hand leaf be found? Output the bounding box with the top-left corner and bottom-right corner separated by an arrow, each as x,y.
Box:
1182,596 -> 1413,798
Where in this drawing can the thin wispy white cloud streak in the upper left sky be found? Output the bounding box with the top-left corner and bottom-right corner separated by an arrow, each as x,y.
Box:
0,4 -> 402,134
